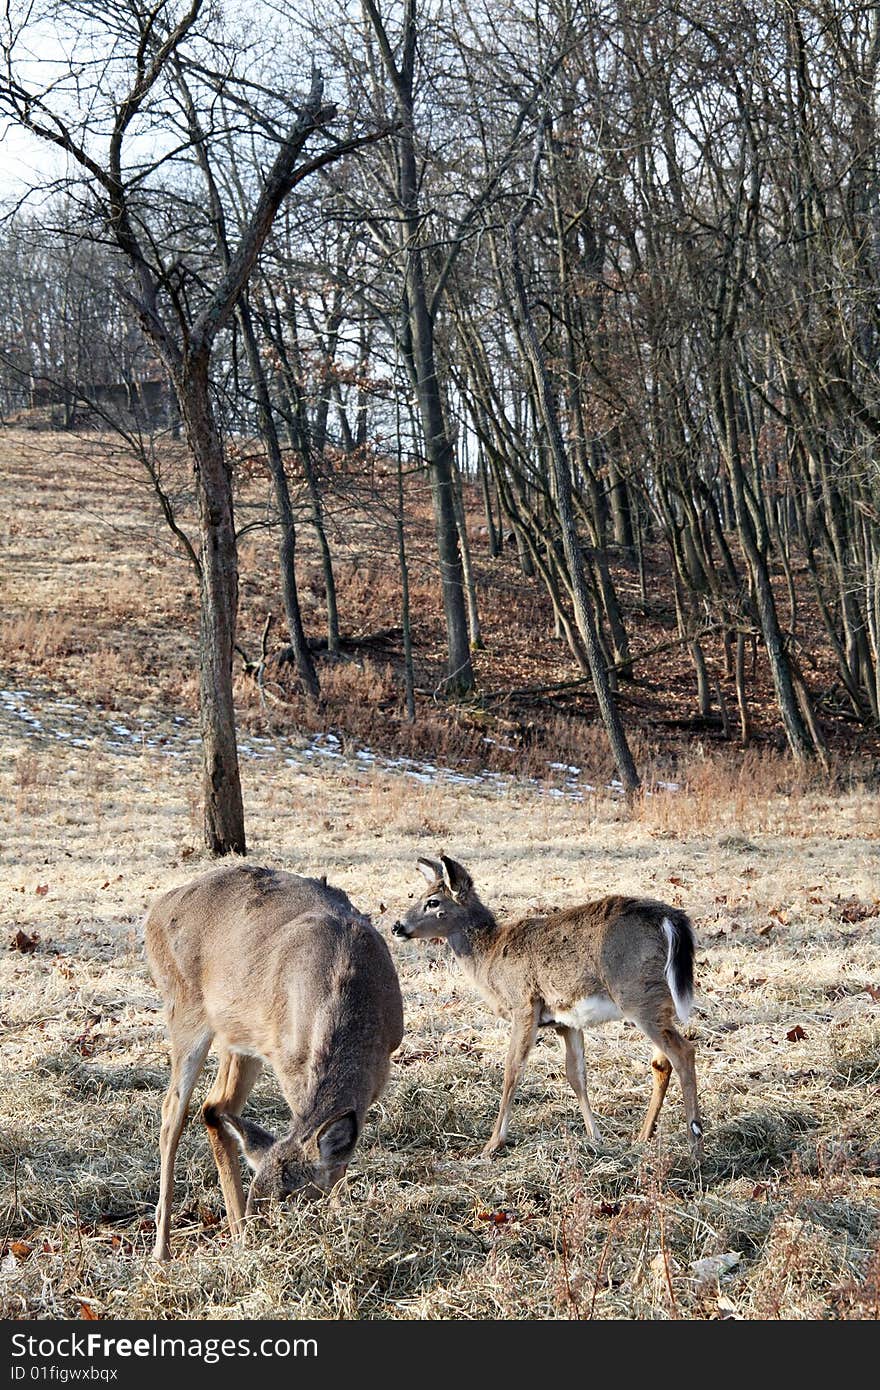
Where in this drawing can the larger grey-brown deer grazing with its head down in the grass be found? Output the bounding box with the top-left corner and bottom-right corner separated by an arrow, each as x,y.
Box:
145,865 -> 403,1259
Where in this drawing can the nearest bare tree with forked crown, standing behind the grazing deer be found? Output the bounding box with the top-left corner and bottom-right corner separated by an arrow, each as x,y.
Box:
0,0 -> 380,855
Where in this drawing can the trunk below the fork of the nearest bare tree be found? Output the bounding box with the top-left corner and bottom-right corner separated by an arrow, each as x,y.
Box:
175,354 -> 246,855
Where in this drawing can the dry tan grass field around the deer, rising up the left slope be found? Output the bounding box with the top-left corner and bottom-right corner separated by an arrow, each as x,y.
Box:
0,432 -> 880,1319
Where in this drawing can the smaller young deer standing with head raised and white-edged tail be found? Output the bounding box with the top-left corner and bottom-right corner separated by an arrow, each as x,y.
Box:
392,855 -> 702,1162
